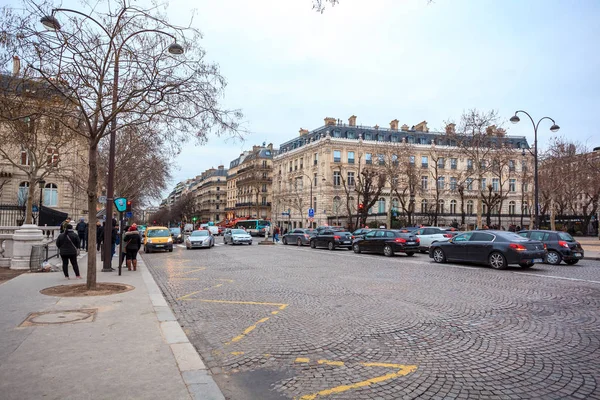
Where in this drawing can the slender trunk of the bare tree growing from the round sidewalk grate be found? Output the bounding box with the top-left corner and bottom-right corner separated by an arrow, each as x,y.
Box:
86,139 -> 98,290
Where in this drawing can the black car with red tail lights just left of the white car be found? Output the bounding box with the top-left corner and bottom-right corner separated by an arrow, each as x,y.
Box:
352,229 -> 419,257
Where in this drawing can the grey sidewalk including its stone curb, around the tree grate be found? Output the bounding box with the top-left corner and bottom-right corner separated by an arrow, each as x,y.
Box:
0,255 -> 224,400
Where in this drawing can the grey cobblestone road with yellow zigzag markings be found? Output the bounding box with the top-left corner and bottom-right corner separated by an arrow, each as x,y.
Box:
143,238 -> 600,400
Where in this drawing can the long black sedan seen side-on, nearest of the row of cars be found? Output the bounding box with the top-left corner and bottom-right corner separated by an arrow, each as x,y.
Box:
429,230 -> 546,269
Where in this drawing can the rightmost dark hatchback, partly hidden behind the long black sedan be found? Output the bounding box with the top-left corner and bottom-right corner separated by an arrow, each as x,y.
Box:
519,230 -> 583,265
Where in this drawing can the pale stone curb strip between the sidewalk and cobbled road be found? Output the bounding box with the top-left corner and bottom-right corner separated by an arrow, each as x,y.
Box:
138,257 -> 225,400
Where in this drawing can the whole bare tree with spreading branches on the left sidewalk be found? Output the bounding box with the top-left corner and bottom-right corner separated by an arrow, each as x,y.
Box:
0,0 -> 241,289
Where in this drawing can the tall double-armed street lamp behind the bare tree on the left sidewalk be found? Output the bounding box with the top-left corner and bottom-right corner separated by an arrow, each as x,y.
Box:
40,8 -> 184,272
